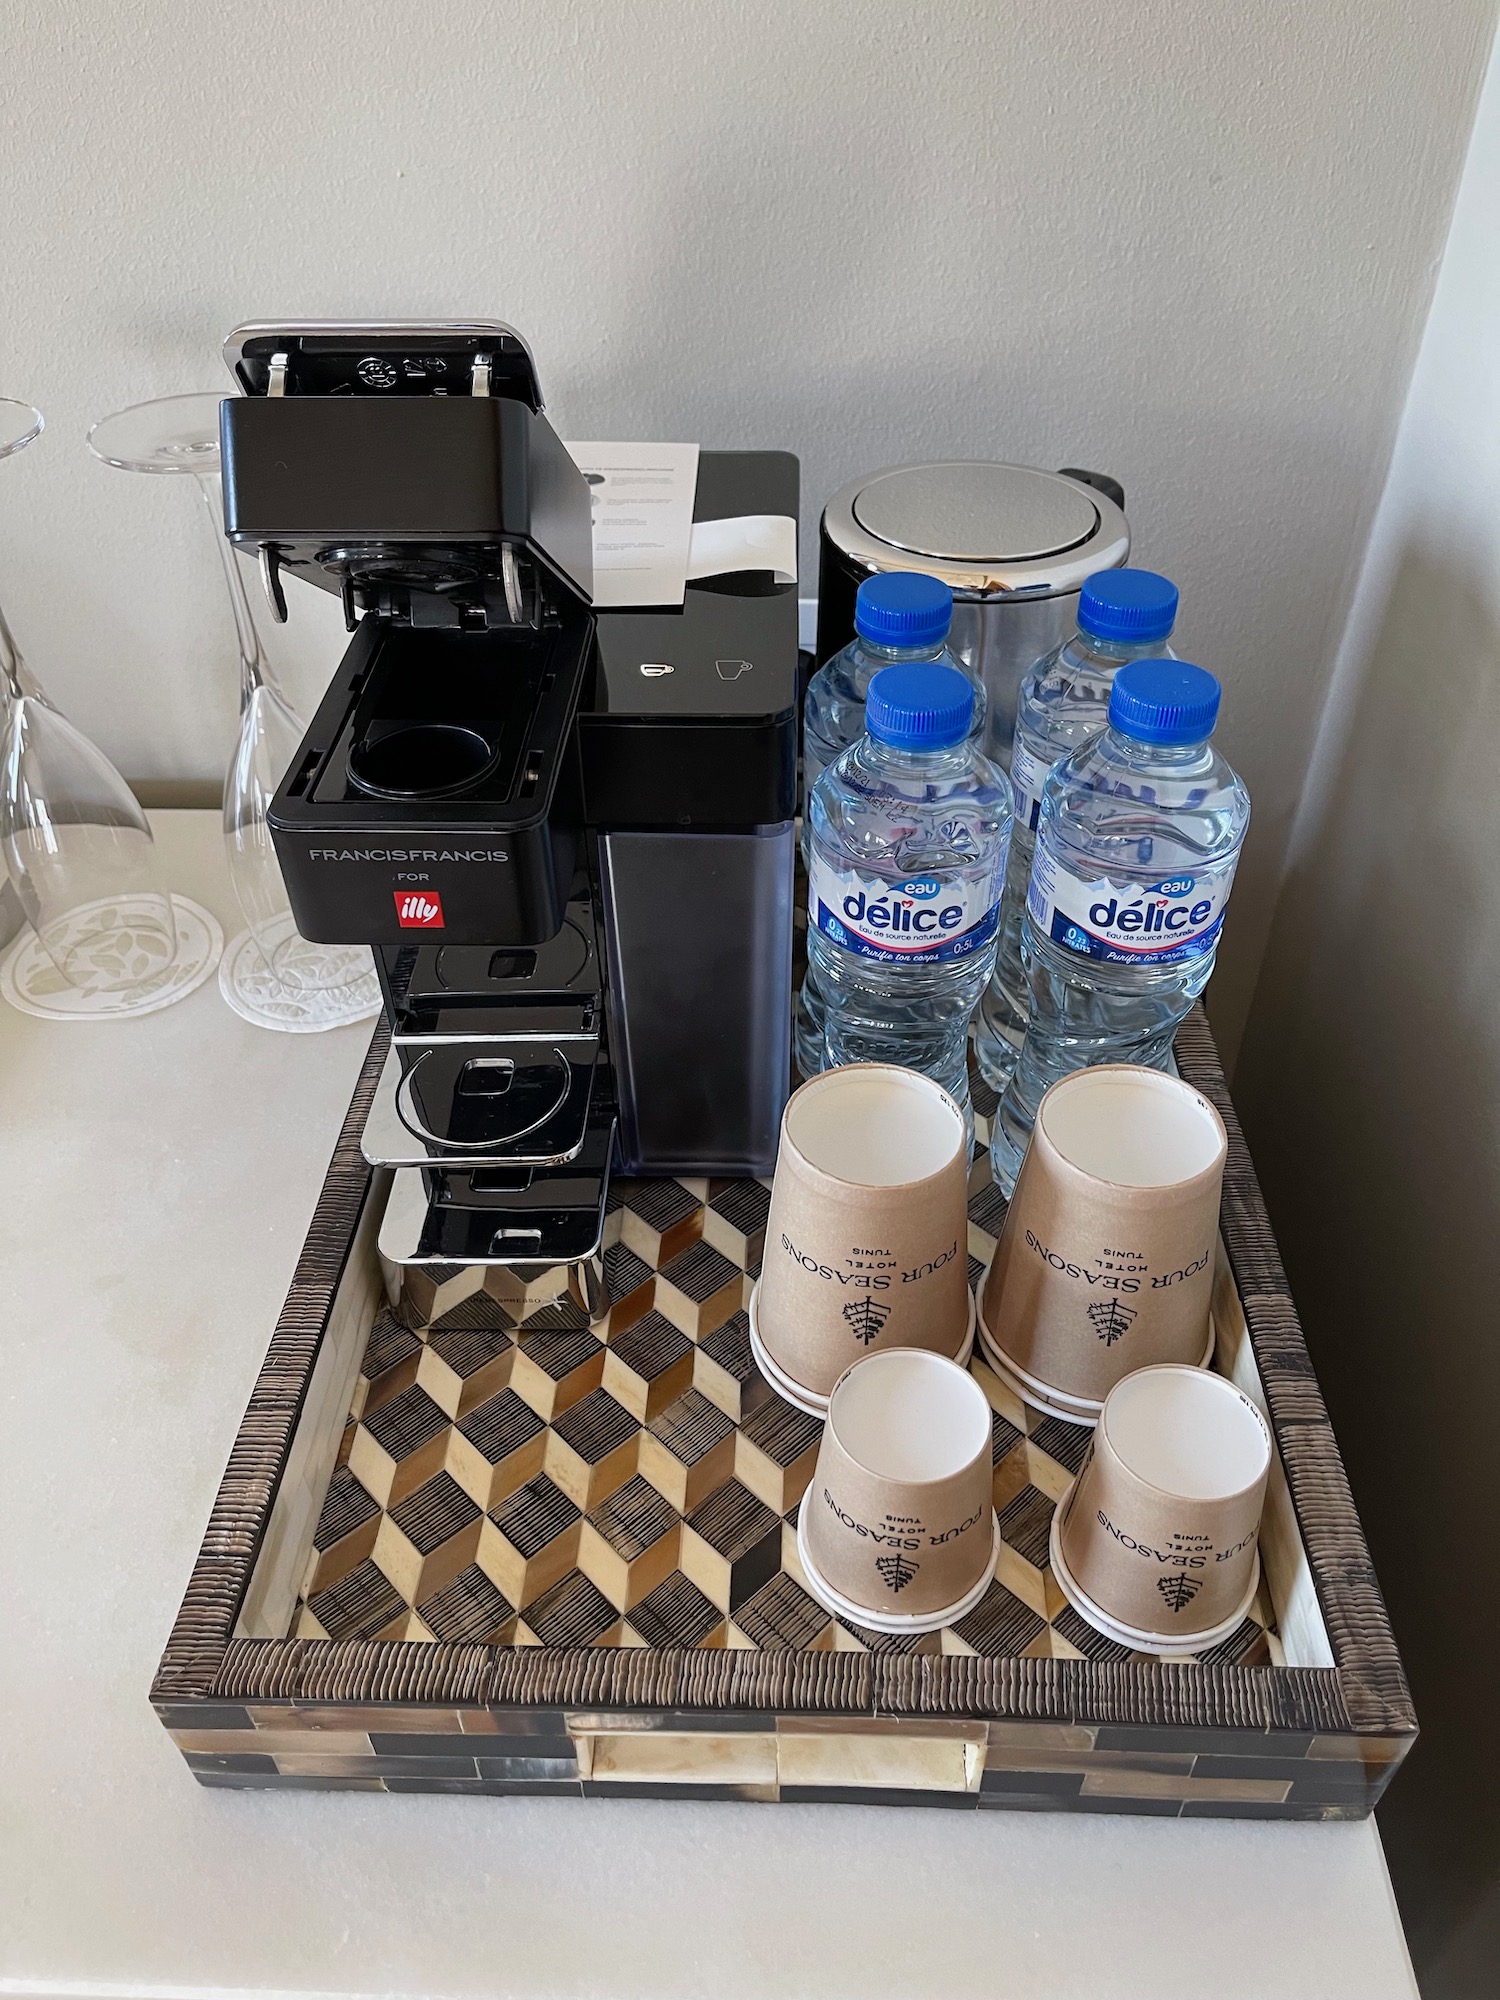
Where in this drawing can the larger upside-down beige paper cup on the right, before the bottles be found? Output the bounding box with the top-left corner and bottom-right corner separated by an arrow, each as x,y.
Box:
980,1064 -> 1226,1424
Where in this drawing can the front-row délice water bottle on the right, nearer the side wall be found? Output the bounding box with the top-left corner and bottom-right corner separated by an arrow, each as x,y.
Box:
992,660 -> 1250,1194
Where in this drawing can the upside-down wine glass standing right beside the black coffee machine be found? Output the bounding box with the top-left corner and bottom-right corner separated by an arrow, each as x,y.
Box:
88,392 -> 378,1026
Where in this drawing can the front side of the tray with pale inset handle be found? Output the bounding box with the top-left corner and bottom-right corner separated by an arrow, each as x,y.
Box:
168,1672 -> 1402,1820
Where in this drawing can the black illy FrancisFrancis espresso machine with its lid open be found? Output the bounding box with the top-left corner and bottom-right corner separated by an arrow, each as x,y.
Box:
222,322 -> 798,1264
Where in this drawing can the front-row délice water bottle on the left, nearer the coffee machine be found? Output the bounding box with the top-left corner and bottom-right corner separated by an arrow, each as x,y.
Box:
808,664 -> 1014,1106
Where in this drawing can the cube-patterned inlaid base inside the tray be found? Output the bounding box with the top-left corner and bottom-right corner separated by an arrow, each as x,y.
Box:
290,1084 -> 1282,1666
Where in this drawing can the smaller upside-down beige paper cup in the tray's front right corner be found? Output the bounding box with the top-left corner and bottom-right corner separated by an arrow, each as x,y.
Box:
1052,1366 -> 1272,1650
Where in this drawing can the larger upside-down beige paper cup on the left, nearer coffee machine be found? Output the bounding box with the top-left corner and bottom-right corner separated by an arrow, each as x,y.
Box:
750,1062 -> 972,1410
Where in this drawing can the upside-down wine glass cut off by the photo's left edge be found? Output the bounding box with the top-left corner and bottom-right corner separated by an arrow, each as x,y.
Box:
0,400 -> 178,994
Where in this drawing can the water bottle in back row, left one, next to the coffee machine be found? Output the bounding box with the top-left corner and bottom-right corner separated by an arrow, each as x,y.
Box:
792,570 -> 986,1076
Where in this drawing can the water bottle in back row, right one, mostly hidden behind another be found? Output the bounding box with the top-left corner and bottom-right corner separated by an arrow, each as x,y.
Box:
974,570 -> 1178,1090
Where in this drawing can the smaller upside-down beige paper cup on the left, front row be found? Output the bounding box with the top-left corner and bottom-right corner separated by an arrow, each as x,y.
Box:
798,1348 -> 996,1632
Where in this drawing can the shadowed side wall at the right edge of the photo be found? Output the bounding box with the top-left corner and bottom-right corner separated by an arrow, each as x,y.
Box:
1236,27 -> 1500,2000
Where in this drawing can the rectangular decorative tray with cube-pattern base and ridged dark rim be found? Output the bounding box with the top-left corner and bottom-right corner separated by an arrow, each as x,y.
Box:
152,1012 -> 1416,1818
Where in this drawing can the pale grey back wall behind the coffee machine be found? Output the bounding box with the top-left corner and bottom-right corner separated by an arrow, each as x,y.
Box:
0,0 -> 1494,1042
